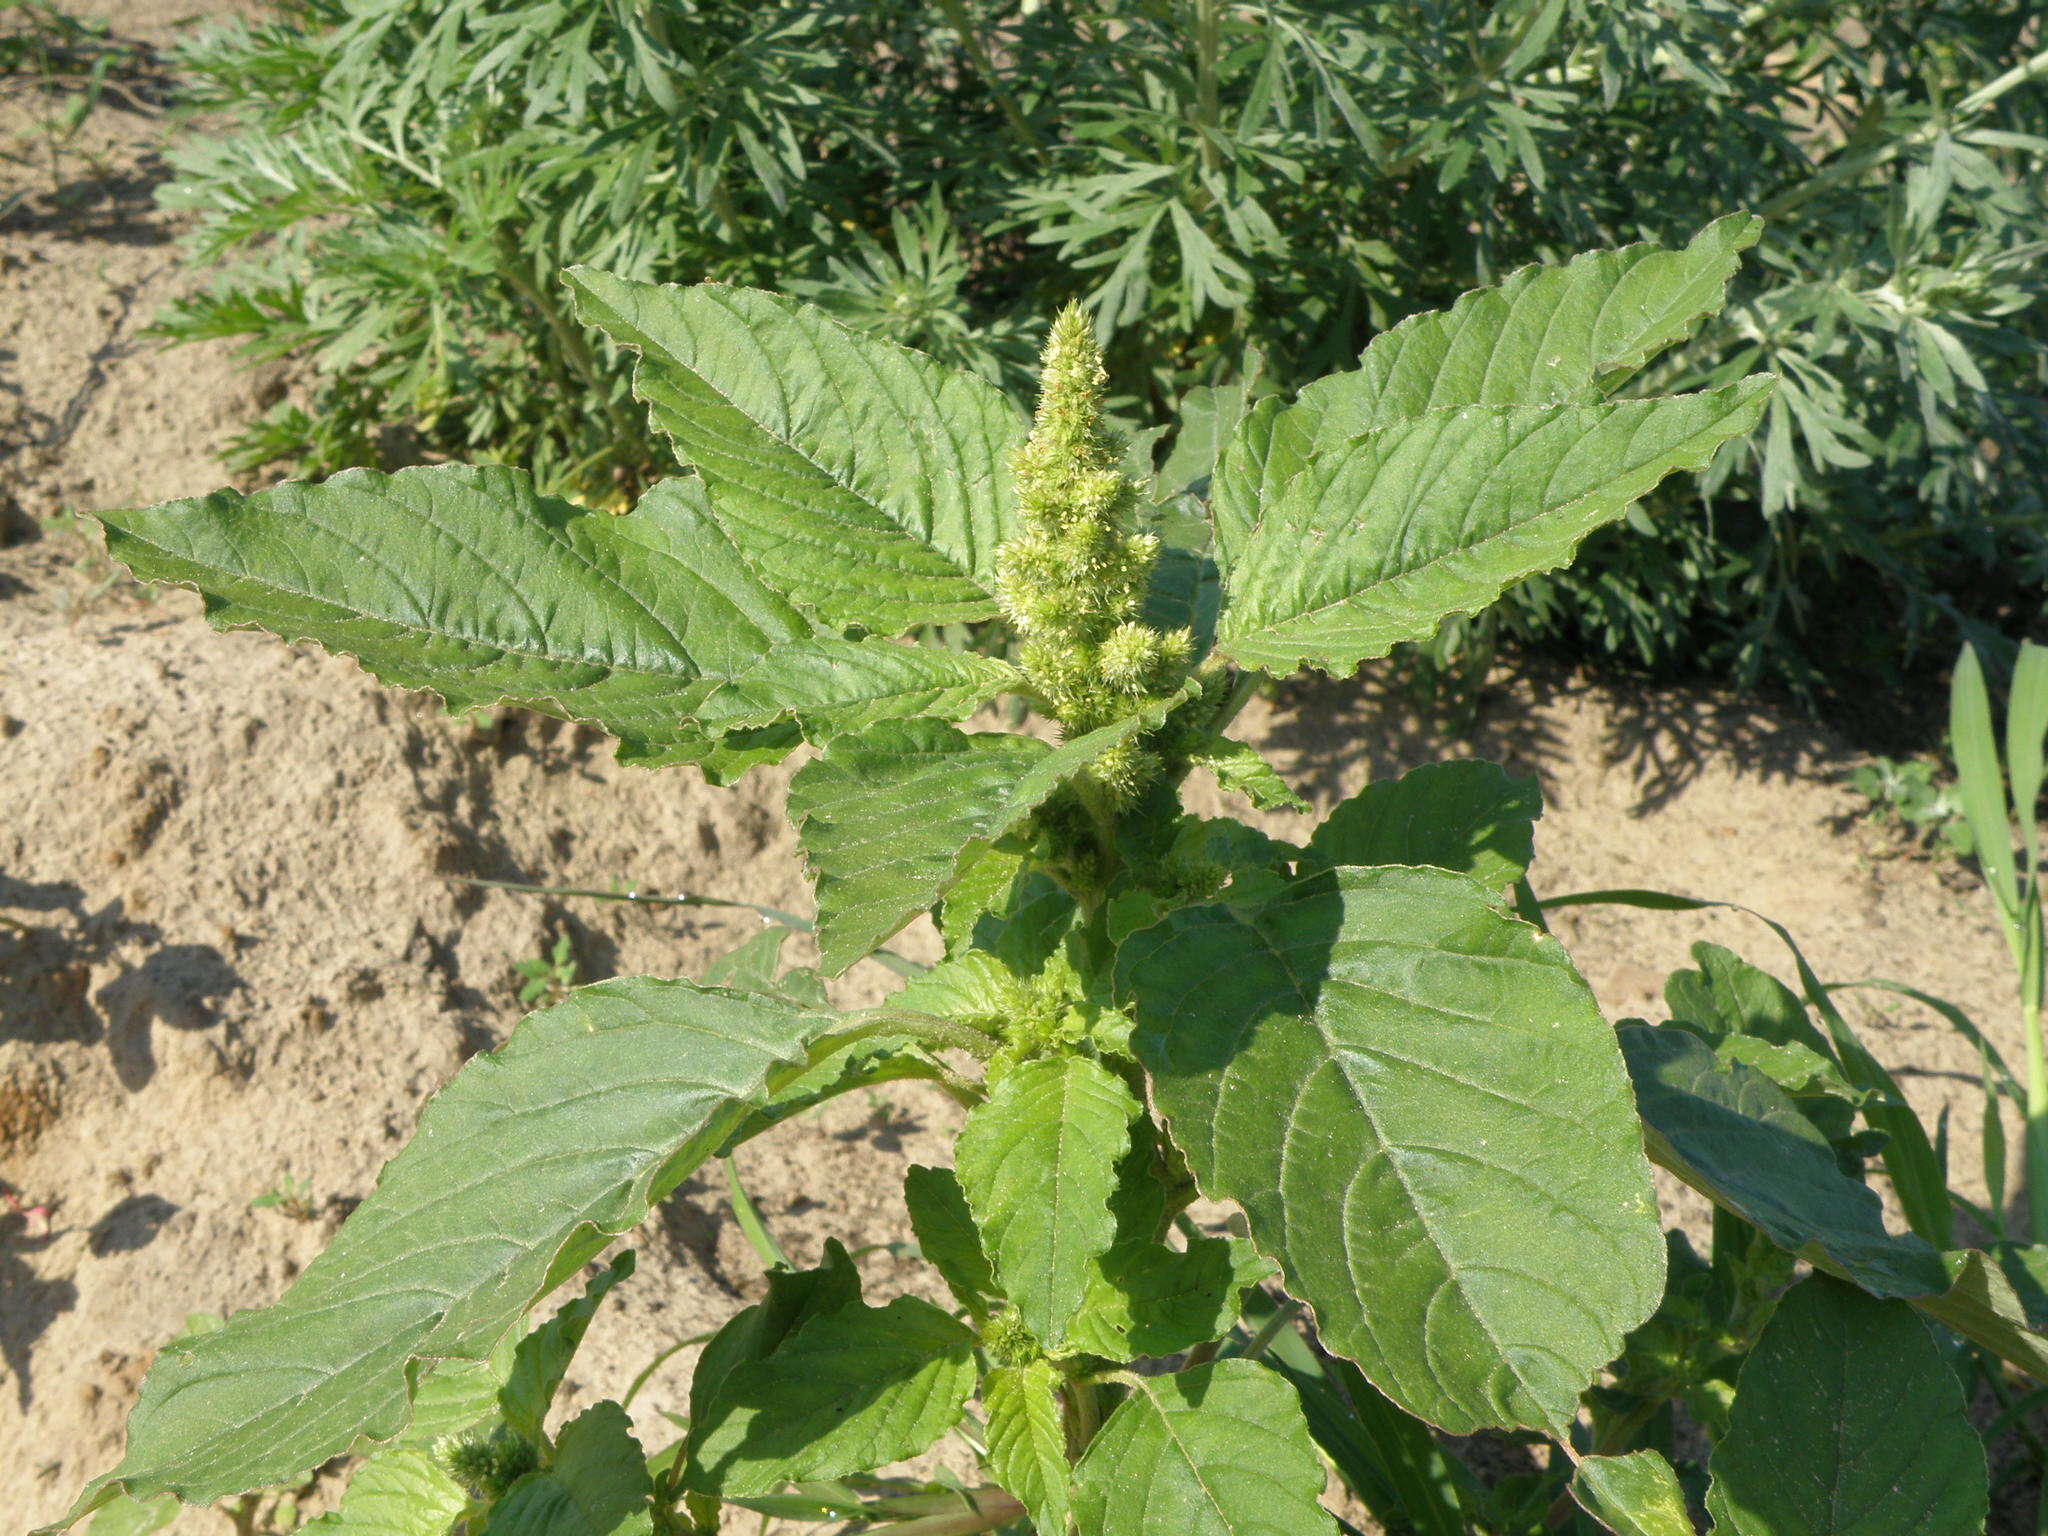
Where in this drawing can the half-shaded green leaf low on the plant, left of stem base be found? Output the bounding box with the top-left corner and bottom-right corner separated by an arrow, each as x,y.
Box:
684,1296 -> 975,1497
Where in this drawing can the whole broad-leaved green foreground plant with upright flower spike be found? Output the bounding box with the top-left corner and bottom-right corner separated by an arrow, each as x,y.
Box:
56,217 -> 2048,1536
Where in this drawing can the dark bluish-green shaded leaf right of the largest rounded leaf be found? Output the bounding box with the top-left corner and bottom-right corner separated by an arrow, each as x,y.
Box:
1618,1024 -> 1948,1296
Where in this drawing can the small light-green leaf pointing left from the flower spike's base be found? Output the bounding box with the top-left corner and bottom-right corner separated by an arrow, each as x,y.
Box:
692,635 -> 1022,743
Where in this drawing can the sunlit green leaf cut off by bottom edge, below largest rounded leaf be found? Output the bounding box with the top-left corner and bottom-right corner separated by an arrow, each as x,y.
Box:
1073,1360 -> 1335,1536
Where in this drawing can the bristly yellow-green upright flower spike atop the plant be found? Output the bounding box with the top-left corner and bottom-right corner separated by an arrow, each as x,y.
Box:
995,305 -> 1194,799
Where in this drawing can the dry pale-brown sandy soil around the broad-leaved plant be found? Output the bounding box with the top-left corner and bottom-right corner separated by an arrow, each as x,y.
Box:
0,6 -> 2017,1532
